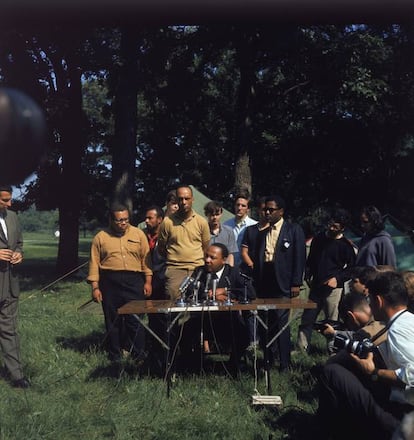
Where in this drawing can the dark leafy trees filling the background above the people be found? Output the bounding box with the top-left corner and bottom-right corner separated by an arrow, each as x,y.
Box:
0,24 -> 414,266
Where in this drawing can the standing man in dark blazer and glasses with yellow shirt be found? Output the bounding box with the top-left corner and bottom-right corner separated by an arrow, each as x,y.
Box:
253,195 -> 306,371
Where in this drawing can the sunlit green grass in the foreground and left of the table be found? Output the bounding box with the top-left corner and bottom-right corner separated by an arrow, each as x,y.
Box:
0,240 -> 325,440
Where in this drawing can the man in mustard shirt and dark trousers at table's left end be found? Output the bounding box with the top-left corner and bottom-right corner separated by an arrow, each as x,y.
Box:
87,205 -> 152,370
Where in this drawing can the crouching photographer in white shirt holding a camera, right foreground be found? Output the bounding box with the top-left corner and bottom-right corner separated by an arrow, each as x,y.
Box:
318,272 -> 414,440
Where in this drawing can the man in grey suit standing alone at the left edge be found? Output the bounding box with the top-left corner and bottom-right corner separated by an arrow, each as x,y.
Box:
0,185 -> 30,388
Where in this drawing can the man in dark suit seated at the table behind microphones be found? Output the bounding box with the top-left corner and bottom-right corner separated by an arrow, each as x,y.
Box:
181,243 -> 256,368
